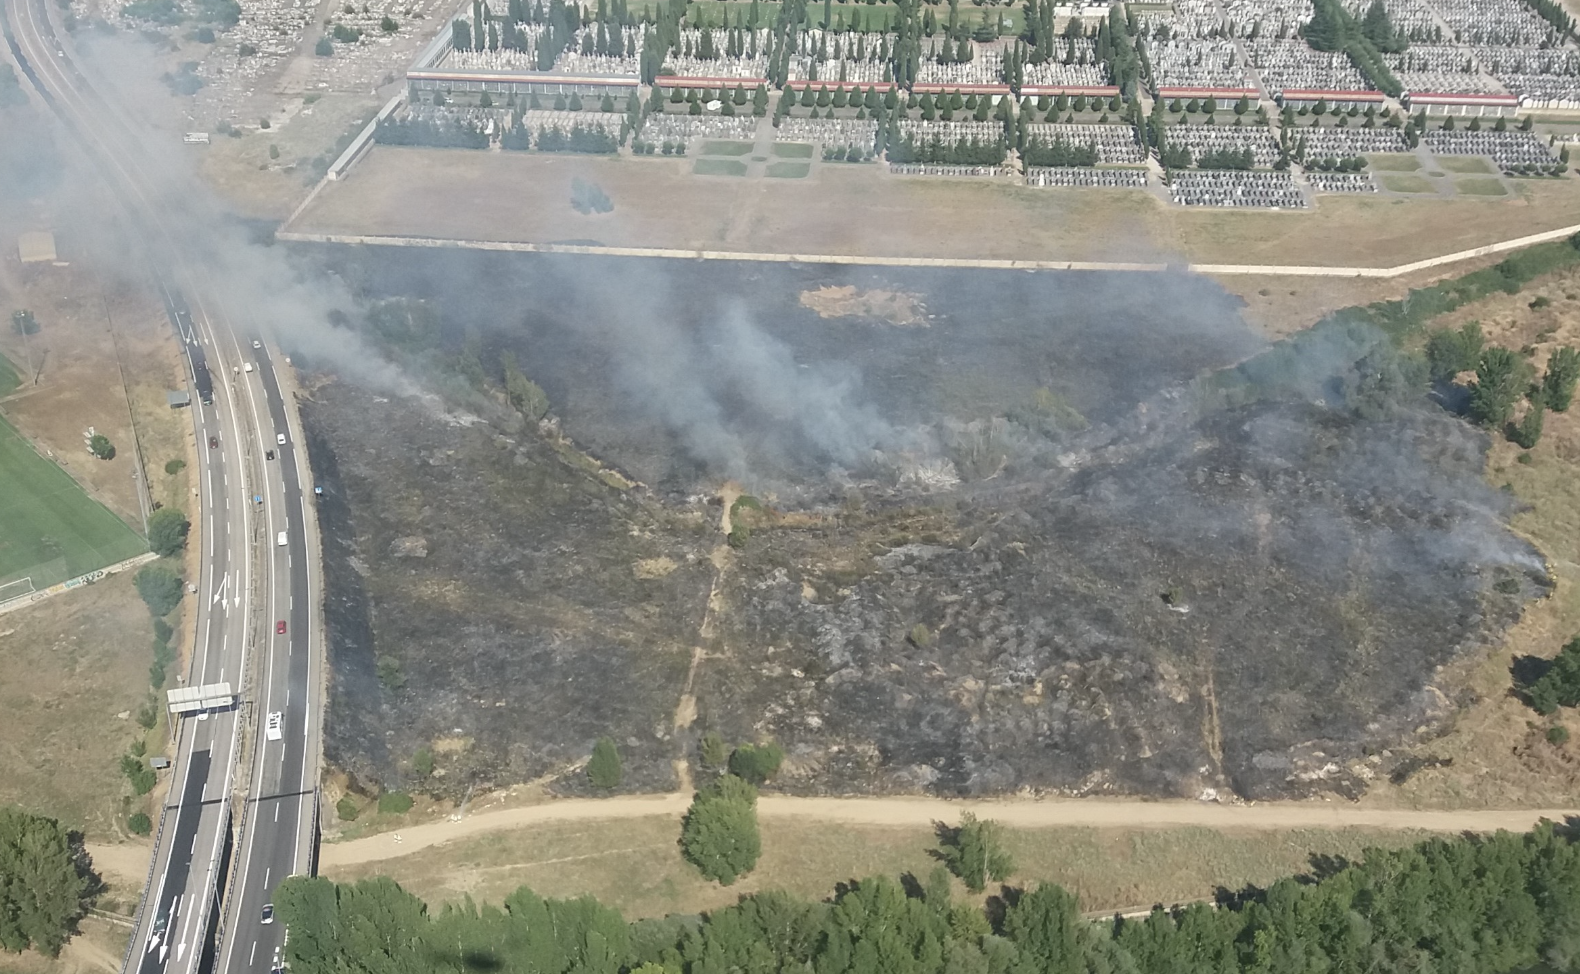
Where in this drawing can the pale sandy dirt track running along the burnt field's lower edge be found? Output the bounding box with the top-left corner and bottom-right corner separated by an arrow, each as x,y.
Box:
319,794 -> 1577,870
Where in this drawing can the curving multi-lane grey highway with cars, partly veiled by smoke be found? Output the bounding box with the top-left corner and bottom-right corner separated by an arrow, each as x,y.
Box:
0,0 -> 322,974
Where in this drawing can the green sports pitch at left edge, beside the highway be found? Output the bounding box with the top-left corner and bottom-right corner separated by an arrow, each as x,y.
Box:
0,419 -> 149,588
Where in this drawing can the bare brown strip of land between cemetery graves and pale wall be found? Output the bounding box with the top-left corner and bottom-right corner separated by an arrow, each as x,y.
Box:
291,145 -> 1580,266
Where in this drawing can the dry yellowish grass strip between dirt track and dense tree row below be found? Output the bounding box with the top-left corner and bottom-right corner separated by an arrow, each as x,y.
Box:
330,817 -> 1440,919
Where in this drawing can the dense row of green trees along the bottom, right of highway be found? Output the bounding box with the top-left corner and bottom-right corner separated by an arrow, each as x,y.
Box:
275,828 -> 1580,974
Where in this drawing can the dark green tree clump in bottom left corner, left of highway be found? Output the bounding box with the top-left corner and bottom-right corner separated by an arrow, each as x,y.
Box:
0,805 -> 101,957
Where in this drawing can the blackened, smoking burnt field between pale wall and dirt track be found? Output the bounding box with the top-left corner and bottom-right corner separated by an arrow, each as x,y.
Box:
299,251 -> 1547,797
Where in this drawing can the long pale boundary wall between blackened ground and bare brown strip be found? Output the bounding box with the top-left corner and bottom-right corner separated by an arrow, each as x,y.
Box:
277,225 -> 1580,278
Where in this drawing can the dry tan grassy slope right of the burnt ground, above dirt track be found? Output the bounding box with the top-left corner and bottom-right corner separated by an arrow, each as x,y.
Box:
1368,270 -> 1580,808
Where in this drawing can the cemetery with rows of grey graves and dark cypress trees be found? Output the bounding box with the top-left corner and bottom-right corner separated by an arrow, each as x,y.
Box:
336,0 -> 1580,209
